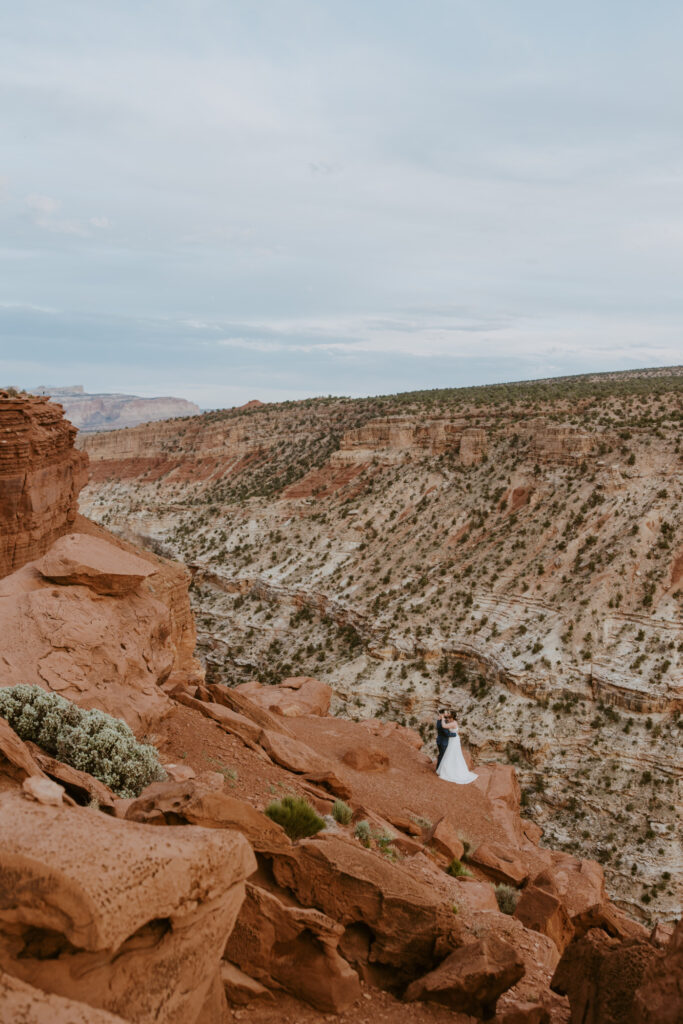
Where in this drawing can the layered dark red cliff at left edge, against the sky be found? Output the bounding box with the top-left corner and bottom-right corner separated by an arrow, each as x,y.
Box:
0,391 -> 88,578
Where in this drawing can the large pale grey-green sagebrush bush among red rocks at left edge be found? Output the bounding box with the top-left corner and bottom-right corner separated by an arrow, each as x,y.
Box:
0,683 -> 166,797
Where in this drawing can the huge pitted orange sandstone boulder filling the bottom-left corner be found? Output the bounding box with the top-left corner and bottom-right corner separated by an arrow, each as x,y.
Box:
0,792 -> 256,1024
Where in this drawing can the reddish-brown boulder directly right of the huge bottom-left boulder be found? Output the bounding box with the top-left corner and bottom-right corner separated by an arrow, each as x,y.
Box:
225,883 -> 360,1013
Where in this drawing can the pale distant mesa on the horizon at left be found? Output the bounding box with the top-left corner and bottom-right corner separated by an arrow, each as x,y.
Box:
32,384 -> 201,433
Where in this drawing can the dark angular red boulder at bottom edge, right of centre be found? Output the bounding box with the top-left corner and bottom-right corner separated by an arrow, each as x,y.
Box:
404,935 -> 524,1018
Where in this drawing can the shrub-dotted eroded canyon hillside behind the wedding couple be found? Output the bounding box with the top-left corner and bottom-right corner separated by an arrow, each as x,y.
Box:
82,368 -> 683,921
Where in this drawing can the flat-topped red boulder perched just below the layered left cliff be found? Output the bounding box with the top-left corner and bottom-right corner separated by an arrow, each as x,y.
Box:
36,534 -> 157,597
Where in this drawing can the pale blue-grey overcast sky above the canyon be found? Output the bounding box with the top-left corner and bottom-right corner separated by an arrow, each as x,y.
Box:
0,0 -> 683,408
